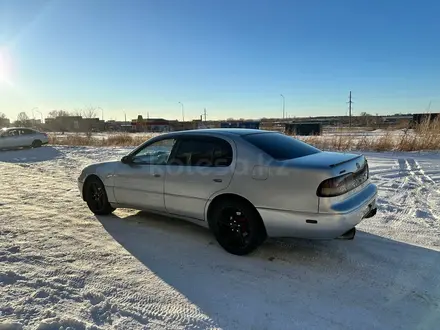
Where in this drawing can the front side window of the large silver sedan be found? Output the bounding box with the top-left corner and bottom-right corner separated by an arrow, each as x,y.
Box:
131,139 -> 176,165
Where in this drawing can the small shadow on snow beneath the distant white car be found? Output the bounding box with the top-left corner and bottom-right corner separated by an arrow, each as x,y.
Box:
0,146 -> 61,163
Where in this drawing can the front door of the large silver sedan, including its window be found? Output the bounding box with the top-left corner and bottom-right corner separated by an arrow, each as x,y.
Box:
113,138 -> 175,211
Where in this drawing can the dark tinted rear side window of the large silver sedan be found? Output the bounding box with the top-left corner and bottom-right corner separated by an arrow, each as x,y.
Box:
170,138 -> 232,167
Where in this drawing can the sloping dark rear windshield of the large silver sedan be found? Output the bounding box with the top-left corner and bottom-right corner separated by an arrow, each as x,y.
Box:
242,133 -> 321,160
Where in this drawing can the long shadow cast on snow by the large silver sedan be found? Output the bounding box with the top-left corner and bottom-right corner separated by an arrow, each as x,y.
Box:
98,212 -> 440,329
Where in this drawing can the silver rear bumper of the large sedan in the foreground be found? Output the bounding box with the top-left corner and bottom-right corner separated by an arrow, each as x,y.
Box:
257,184 -> 377,239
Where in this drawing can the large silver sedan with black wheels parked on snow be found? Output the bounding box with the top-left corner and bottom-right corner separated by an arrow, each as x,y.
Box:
78,129 -> 377,255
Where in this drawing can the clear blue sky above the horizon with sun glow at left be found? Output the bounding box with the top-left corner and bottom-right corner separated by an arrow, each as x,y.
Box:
0,0 -> 440,120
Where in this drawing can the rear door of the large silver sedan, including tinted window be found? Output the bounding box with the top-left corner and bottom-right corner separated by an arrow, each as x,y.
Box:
164,136 -> 235,220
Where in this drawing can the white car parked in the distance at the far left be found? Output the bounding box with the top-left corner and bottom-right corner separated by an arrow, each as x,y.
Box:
0,127 -> 49,149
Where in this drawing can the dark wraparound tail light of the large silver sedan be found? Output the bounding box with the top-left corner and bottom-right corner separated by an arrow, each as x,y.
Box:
316,163 -> 369,197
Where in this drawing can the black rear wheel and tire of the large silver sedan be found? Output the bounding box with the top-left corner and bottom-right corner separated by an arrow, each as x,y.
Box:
208,199 -> 267,256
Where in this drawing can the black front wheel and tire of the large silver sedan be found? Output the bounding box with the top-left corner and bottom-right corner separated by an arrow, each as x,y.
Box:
84,177 -> 115,215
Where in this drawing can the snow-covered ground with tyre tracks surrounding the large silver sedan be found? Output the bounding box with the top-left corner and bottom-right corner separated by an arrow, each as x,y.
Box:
0,147 -> 440,330
